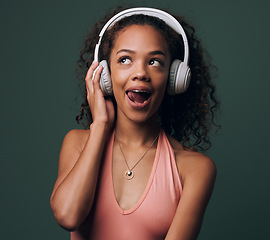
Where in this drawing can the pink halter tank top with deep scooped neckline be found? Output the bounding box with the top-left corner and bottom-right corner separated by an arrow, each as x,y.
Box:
71,130 -> 182,240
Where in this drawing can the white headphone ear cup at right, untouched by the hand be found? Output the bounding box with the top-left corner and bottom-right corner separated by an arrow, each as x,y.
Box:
167,59 -> 191,95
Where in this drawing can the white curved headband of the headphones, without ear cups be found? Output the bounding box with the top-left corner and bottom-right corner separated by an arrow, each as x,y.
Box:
94,7 -> 189,65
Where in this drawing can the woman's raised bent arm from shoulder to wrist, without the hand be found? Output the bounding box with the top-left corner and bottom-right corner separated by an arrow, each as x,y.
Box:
50,125 -> 108,230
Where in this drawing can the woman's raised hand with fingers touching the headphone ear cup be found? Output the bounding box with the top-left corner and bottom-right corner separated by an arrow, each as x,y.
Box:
85,61 -> 115,129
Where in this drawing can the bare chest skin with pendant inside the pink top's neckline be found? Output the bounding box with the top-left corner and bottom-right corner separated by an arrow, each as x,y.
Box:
112,145 -> 156,210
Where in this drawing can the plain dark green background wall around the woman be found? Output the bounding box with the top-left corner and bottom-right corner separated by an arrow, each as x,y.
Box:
0,0 -> 270,240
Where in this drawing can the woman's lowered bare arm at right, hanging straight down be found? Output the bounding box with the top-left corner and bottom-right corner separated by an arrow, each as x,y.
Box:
166,153 -> 216,240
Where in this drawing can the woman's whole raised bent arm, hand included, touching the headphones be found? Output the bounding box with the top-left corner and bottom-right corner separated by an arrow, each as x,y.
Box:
50,63 -> 114,230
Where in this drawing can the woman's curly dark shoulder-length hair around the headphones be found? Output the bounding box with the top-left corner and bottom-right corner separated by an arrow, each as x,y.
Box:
76,8 -> 219,151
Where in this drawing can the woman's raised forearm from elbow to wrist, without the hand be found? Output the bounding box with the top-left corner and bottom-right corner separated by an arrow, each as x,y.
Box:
51,124 -> 107,230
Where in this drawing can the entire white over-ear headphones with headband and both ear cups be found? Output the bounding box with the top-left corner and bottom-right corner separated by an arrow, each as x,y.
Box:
94,8 -> 191,96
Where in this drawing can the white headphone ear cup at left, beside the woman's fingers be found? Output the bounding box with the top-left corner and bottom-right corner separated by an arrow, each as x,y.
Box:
99,60 -> 113,96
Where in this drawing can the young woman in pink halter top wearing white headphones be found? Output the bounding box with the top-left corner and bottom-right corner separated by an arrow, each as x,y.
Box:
50,8 -> 217,240
